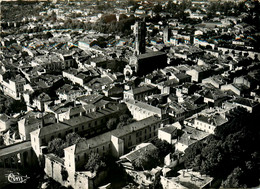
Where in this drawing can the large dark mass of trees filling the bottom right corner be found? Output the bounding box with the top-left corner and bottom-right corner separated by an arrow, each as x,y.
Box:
183,109 -> 260,188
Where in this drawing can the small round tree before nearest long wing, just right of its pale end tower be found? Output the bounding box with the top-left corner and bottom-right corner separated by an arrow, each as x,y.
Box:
85,152 -> 106,173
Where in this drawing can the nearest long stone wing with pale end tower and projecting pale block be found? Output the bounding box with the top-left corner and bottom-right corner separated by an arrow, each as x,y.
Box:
64,116 -> 162,171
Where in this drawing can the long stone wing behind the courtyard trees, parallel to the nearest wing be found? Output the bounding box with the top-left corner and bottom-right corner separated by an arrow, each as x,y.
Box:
30,104 -> 127,156
